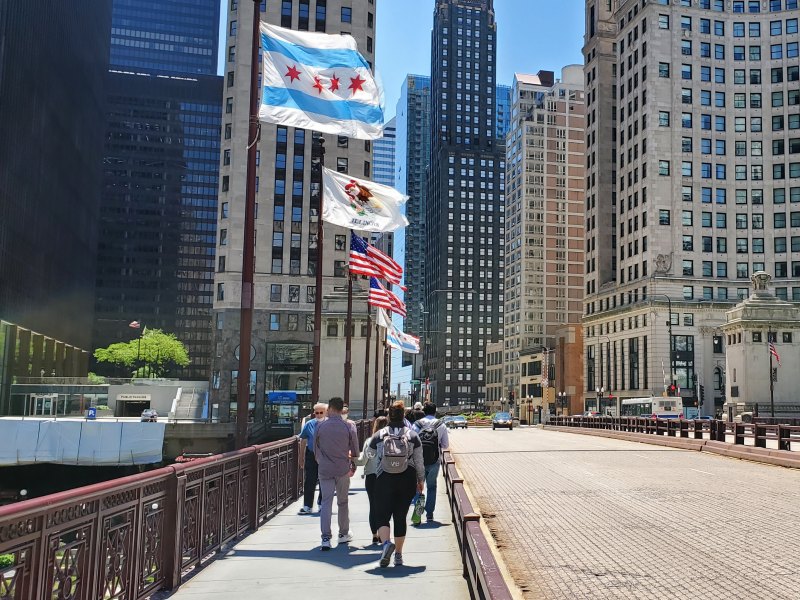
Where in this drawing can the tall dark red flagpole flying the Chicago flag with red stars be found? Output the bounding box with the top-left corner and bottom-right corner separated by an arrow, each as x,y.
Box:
236,0 -> 261,448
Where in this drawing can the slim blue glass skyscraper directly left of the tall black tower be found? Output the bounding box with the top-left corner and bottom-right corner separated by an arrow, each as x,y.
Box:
395,75 -> 431,379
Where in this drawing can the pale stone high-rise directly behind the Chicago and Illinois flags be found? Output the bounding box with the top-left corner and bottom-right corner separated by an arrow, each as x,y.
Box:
211,0 -> 388,426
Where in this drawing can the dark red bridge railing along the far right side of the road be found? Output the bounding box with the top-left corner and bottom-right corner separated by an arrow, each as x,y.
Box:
550,416 -> 800,451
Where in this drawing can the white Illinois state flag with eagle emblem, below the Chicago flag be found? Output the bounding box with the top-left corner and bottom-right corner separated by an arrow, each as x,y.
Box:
322,167 -> 408,231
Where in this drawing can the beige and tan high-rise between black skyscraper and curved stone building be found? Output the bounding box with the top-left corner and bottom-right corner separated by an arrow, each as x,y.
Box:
503,65 -> 585,398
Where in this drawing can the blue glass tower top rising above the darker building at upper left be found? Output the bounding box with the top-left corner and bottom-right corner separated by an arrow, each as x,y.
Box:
111,0 -> 220,75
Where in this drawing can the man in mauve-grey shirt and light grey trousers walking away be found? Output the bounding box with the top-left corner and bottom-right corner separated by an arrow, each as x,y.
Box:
314,397 -> 358,550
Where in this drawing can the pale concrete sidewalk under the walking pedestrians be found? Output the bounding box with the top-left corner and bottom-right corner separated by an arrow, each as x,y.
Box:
169,469 -> 469,600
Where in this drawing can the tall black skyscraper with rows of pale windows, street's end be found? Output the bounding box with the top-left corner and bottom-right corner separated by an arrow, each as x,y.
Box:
423,0 -> 505,406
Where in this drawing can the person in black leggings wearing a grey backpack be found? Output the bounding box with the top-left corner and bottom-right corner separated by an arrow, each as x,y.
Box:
368,400 -> 425,567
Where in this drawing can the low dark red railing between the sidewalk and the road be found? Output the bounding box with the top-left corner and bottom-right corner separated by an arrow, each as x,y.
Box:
441,450 -> 512,600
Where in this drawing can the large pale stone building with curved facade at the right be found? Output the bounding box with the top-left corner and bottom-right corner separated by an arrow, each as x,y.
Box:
584,0 -> 800,415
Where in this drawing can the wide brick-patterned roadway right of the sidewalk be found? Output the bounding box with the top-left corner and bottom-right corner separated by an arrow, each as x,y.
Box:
450,427 -> 800,600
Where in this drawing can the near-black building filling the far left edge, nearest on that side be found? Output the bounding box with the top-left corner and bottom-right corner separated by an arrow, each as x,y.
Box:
0,0 -> 111,414
